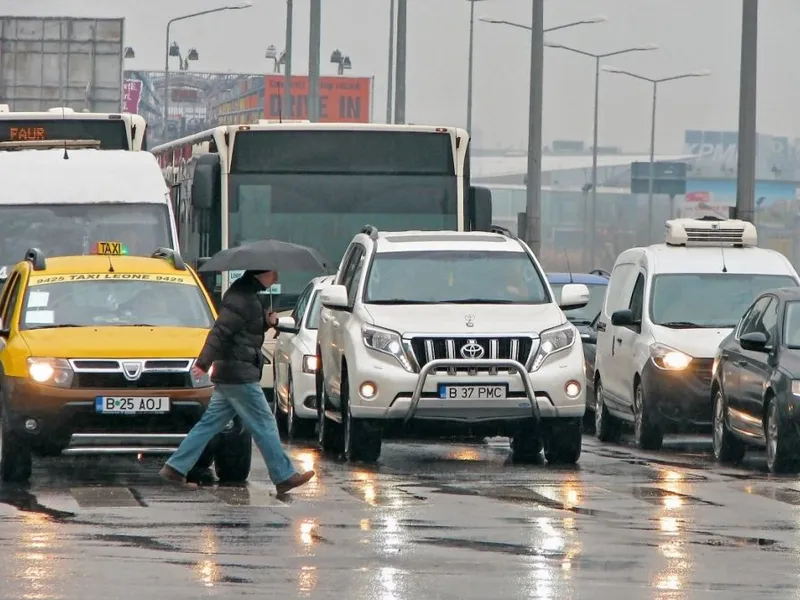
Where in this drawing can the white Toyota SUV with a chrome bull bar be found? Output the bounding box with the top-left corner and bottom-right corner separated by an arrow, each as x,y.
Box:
317,226 -> 589,463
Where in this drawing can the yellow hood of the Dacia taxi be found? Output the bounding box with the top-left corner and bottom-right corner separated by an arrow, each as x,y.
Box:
20,327 -> 208,358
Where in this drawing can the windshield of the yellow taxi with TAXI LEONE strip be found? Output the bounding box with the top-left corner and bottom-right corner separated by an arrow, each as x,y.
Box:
20,273 -> 213,329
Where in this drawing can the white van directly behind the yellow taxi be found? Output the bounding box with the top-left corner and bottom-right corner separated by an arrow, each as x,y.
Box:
0,148 -> 178,285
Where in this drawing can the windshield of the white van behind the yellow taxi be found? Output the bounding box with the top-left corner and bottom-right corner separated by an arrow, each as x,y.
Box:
0,204 -> 172,278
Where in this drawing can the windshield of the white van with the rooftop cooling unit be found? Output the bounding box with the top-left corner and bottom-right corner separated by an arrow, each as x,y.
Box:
650,273 -> 797,327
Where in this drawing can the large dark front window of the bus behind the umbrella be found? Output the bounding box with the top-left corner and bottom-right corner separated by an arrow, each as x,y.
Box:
229,130 -> 459,310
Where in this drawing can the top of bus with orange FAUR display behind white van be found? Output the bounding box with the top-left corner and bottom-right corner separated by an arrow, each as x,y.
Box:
0,104 -> 147,151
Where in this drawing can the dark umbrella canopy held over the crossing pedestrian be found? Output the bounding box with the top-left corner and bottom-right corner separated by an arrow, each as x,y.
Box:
199,240 -> 328,272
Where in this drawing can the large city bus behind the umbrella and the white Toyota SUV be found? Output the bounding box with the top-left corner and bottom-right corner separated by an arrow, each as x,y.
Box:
152,120 -> 491,394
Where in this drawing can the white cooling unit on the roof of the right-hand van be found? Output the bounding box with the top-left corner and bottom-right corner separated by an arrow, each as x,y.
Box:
665,217 -> 758,248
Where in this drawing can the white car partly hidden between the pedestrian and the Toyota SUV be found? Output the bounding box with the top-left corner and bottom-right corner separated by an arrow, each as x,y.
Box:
273,275 -> 333,439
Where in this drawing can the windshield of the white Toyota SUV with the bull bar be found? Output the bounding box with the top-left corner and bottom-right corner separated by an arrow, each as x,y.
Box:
364,250 -> 550,304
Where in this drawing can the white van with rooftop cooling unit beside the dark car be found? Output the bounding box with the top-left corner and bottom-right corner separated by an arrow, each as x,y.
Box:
594,217 -> 800,450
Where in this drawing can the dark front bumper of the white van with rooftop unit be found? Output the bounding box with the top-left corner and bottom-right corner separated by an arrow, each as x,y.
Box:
642,359 -> 713,432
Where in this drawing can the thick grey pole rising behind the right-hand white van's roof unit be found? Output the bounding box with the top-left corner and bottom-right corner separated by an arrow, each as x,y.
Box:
736,0 -> 758,223
